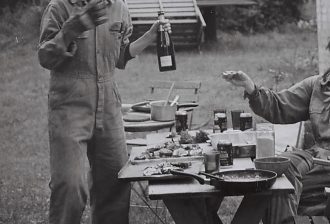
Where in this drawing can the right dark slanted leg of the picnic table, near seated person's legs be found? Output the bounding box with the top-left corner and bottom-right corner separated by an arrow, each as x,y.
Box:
231,194 -> 272,224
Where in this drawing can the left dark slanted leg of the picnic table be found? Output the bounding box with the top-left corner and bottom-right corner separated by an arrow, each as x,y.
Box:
163,195 -> 223,224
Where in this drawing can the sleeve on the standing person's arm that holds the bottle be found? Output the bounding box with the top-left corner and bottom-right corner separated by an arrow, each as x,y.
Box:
116,10 -> 133,69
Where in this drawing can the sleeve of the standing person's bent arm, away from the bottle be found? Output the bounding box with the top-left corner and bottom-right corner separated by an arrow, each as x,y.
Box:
38,4 -> 83,70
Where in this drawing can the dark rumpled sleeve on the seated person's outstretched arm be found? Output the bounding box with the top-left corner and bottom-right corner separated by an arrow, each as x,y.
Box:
248,76 -> 315,124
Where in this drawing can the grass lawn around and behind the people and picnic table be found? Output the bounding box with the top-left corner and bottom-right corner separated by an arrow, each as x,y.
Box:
0,28 -> 317,224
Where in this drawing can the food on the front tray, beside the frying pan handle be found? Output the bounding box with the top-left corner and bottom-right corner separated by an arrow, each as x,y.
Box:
143,162 -> 191,176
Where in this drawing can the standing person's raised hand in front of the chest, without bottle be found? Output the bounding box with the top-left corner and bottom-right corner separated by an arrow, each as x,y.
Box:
82,0 -> 108,29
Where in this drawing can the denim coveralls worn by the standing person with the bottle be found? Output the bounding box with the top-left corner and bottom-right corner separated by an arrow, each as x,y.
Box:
38,0 -> 132,224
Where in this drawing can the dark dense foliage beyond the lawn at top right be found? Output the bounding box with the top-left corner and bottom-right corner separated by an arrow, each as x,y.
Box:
216,0 -> 308,32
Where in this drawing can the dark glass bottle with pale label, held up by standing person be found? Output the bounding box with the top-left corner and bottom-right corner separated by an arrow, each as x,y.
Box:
157,11 -> 176,72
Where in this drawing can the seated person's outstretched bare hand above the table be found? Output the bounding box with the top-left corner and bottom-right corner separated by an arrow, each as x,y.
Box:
222,71 -> 255,94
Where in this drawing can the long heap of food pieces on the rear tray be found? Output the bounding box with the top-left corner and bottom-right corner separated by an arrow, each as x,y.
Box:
134,142 -> 203,160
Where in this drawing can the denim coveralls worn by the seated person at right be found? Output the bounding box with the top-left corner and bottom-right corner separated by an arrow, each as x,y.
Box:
248,73 -> 330,224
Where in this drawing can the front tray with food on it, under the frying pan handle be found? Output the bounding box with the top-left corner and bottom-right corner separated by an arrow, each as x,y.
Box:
118,158 -> 203,181
